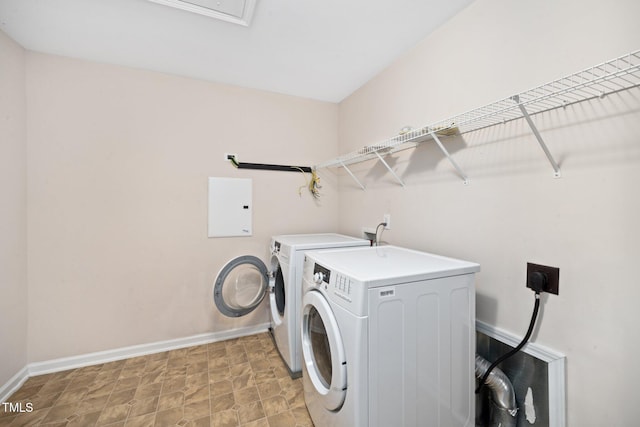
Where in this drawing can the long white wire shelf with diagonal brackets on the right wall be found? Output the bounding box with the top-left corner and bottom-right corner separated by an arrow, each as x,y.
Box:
315,50 -> 640,171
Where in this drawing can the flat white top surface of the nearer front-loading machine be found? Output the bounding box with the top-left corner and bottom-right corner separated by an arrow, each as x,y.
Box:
307,246 -> 480,286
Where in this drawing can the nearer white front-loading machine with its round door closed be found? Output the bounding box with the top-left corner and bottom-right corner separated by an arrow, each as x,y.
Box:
301,246 -> 480,427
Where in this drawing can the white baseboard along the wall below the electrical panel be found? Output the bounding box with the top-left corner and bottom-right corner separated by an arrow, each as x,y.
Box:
0,323 -> 270,402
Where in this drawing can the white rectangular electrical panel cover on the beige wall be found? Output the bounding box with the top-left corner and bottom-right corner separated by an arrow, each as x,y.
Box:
209,177 -> 253,237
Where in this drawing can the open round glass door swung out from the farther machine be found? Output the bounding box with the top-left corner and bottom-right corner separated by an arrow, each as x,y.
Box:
213,255 -> 270,317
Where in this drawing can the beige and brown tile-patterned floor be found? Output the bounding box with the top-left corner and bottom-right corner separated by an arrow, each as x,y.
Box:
0,333 -> 313,427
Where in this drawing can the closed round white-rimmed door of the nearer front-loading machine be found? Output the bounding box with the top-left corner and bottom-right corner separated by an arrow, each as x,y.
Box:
302,291 -> 347,411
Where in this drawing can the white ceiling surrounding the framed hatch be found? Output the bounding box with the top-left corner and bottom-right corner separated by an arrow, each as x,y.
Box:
0,0 -> 473,102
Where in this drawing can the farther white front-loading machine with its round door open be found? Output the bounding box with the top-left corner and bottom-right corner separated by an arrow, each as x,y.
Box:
213,233 -> 370,378
